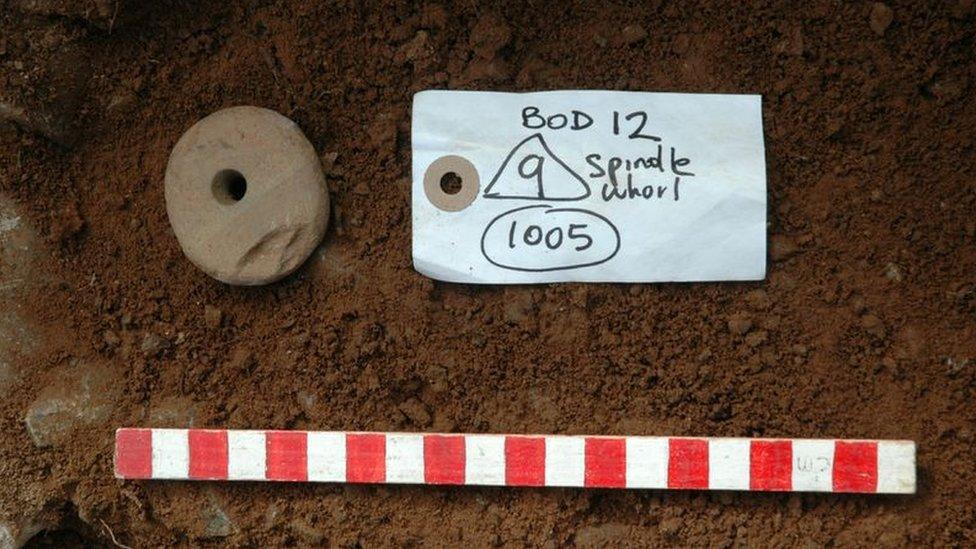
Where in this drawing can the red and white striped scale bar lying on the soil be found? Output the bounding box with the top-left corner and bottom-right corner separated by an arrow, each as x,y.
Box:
115,429 -> 915,494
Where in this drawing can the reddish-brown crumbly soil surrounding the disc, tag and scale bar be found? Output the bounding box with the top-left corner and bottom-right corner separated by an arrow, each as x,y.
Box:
0,0 -> 976,546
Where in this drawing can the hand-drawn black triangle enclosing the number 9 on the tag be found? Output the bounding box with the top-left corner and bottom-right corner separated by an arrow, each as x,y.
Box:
485,133 -> 590,201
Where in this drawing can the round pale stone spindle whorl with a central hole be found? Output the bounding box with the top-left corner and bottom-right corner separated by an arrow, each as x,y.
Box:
165,106 -> 329,286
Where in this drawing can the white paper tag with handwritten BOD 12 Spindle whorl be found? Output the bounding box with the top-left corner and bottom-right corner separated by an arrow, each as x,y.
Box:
412,91 -> 766,283
